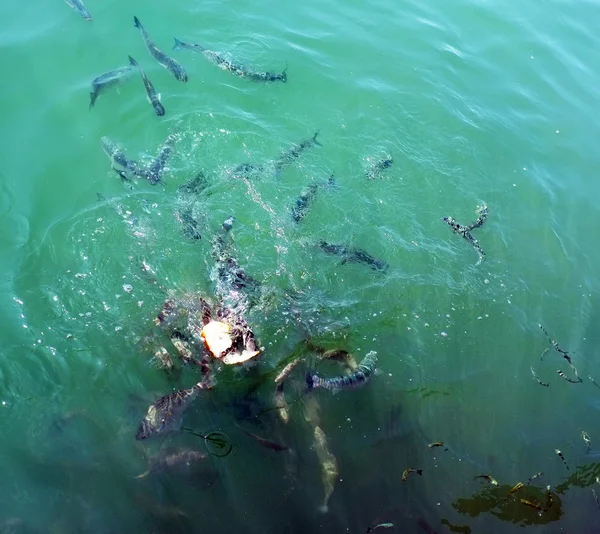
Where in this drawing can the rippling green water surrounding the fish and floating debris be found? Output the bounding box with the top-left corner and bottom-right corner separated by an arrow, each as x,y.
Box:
0,0 -> 600,533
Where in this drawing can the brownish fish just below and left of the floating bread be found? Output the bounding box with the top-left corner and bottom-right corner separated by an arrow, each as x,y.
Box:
135,381 -> 210,440
